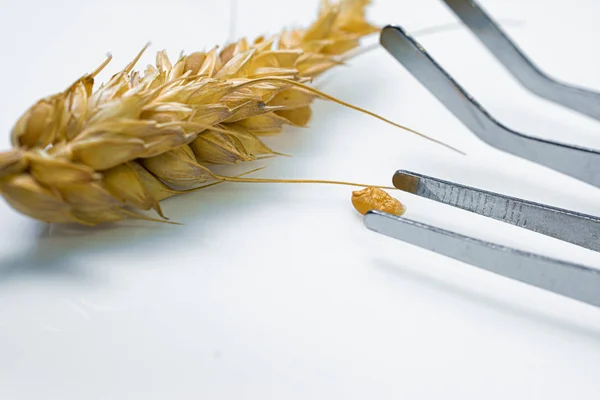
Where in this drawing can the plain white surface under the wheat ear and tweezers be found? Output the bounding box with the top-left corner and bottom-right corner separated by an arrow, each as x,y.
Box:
0,0 -> 600,400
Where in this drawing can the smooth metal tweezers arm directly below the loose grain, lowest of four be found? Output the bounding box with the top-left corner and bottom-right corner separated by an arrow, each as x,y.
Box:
364,211 -> 600,307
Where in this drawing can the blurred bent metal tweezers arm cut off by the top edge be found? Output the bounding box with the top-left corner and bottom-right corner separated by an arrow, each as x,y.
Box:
444,0 -> 600,120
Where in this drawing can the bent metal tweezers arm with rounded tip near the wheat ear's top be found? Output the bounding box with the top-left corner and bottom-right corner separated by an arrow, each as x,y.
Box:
381,26 -> 600,187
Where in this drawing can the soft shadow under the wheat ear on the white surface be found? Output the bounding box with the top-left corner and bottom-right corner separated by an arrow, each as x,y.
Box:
0,180 -> 282,285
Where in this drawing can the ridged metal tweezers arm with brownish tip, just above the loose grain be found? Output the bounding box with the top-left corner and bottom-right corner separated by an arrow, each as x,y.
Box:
393,171 -> 600,251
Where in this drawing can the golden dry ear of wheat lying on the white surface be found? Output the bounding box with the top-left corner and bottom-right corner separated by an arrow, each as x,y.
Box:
0,0 -> 446,225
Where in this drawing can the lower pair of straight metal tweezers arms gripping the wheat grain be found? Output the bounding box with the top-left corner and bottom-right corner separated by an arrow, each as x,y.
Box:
363,171 -> 600,307
